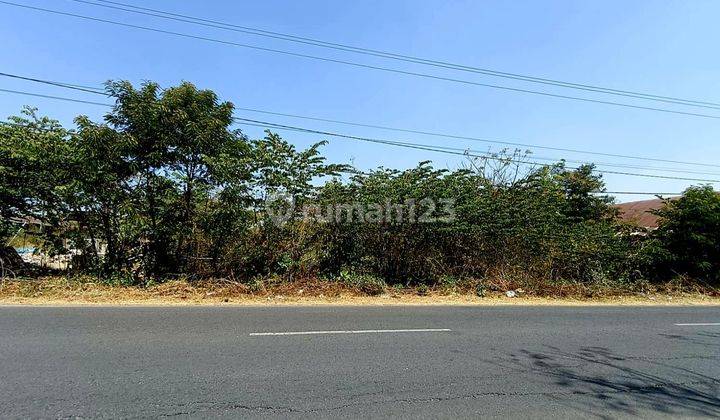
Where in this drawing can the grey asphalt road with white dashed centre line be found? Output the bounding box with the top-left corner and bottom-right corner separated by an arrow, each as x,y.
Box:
0,306 -> 720,418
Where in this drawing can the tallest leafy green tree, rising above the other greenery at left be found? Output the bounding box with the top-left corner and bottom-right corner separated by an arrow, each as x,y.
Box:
105,82 -> 244,276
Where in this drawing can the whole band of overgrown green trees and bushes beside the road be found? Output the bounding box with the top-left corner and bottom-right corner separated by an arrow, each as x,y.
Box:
0,82 -> 720,296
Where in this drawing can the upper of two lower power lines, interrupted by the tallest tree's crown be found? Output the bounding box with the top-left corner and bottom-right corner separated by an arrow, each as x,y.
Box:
0,72 -> 720,171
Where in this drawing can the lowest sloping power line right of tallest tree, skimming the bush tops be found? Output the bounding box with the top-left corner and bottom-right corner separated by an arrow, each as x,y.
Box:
234,117 -> 720,183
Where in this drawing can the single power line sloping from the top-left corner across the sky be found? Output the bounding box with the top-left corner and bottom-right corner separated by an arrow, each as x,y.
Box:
0,0 -> 720,119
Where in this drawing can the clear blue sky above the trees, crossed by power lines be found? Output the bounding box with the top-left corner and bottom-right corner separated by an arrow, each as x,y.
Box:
0,0 -> 720,201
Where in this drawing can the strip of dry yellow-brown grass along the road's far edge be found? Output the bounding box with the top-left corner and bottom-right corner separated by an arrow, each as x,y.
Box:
0,277 -> 720,305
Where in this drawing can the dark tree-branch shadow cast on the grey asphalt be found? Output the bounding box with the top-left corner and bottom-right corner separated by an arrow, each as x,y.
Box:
490,342 -> 720,418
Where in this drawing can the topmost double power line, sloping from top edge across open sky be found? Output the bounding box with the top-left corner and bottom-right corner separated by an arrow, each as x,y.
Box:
72,0 -> 720,109
